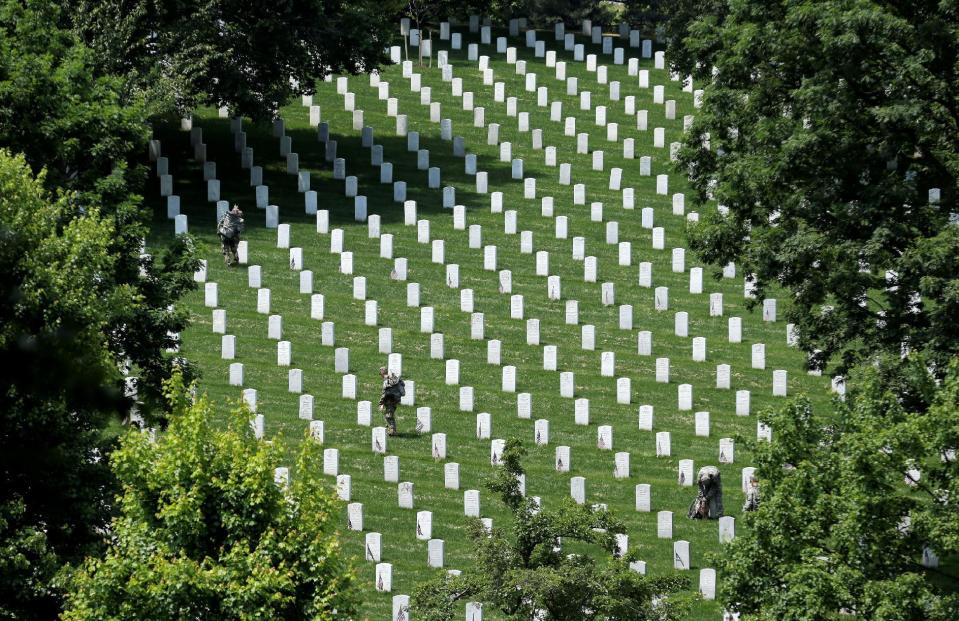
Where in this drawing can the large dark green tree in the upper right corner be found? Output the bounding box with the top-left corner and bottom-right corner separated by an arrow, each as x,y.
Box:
667,0 -> 959,375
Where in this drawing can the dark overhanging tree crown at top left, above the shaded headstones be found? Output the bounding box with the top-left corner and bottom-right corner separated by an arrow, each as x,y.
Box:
68,0 -> 401,119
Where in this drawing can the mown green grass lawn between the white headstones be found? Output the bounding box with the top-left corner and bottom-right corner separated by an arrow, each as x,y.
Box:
149,20 -> 829,619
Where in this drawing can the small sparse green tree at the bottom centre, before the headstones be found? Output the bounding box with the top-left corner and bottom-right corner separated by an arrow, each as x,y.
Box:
413,439 -> 688,621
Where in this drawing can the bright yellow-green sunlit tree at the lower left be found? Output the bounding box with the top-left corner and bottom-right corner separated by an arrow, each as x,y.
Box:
62,376 -> 354,621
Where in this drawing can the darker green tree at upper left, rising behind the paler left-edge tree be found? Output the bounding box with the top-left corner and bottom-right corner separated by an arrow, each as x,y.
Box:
0,0 -> 197,417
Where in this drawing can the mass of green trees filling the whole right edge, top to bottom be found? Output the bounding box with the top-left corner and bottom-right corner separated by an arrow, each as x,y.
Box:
663,0 -> 959,621
